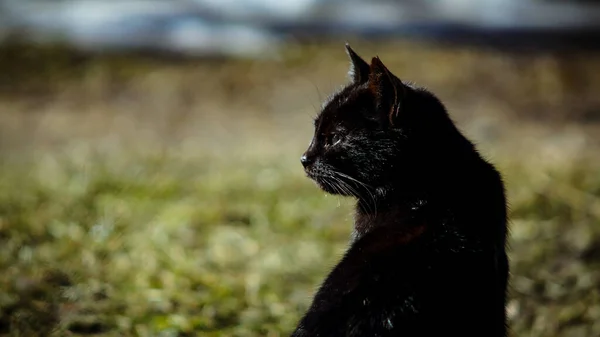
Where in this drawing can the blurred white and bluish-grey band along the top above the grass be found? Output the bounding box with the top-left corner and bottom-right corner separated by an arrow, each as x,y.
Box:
0,0 -> 600,57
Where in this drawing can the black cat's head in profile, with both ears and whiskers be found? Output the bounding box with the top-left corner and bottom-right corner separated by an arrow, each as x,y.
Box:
301,44 -> 452,196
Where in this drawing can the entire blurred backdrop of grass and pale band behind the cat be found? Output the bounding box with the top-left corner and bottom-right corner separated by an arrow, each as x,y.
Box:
0,0 -> 600,337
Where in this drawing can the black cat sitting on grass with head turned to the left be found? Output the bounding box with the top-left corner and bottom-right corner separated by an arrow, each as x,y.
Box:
292,45 -> 509,337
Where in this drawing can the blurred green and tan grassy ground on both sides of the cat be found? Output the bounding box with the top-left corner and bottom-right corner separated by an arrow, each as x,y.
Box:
0,38 -> 600,337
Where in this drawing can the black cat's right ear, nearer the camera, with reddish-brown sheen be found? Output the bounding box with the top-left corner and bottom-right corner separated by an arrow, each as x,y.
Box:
369,56 -> 406,125
